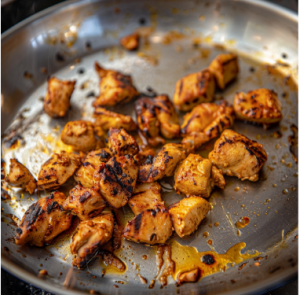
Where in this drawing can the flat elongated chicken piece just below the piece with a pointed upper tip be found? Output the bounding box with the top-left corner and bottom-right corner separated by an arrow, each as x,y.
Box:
94,107 -> 137,131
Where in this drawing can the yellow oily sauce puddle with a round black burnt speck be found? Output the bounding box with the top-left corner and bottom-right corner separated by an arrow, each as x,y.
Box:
171,241 -> 260,285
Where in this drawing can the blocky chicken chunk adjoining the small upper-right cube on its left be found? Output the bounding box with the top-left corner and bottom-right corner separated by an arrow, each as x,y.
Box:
173,69 -> 215,112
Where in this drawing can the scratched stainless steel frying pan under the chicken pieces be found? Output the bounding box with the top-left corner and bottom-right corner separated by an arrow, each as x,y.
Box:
1,0 -> 298,294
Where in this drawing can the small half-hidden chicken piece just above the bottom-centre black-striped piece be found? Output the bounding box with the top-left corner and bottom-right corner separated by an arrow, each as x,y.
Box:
128,182 -> 164,215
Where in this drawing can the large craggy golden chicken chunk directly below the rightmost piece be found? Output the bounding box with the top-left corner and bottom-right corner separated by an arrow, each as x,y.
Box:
208,130 -> 268,181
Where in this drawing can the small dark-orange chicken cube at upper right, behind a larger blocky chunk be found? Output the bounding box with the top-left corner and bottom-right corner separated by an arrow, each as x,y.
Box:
209,53 -> 239,89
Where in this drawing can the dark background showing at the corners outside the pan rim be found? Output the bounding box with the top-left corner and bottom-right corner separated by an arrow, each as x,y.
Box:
1,0 -> 298,295
